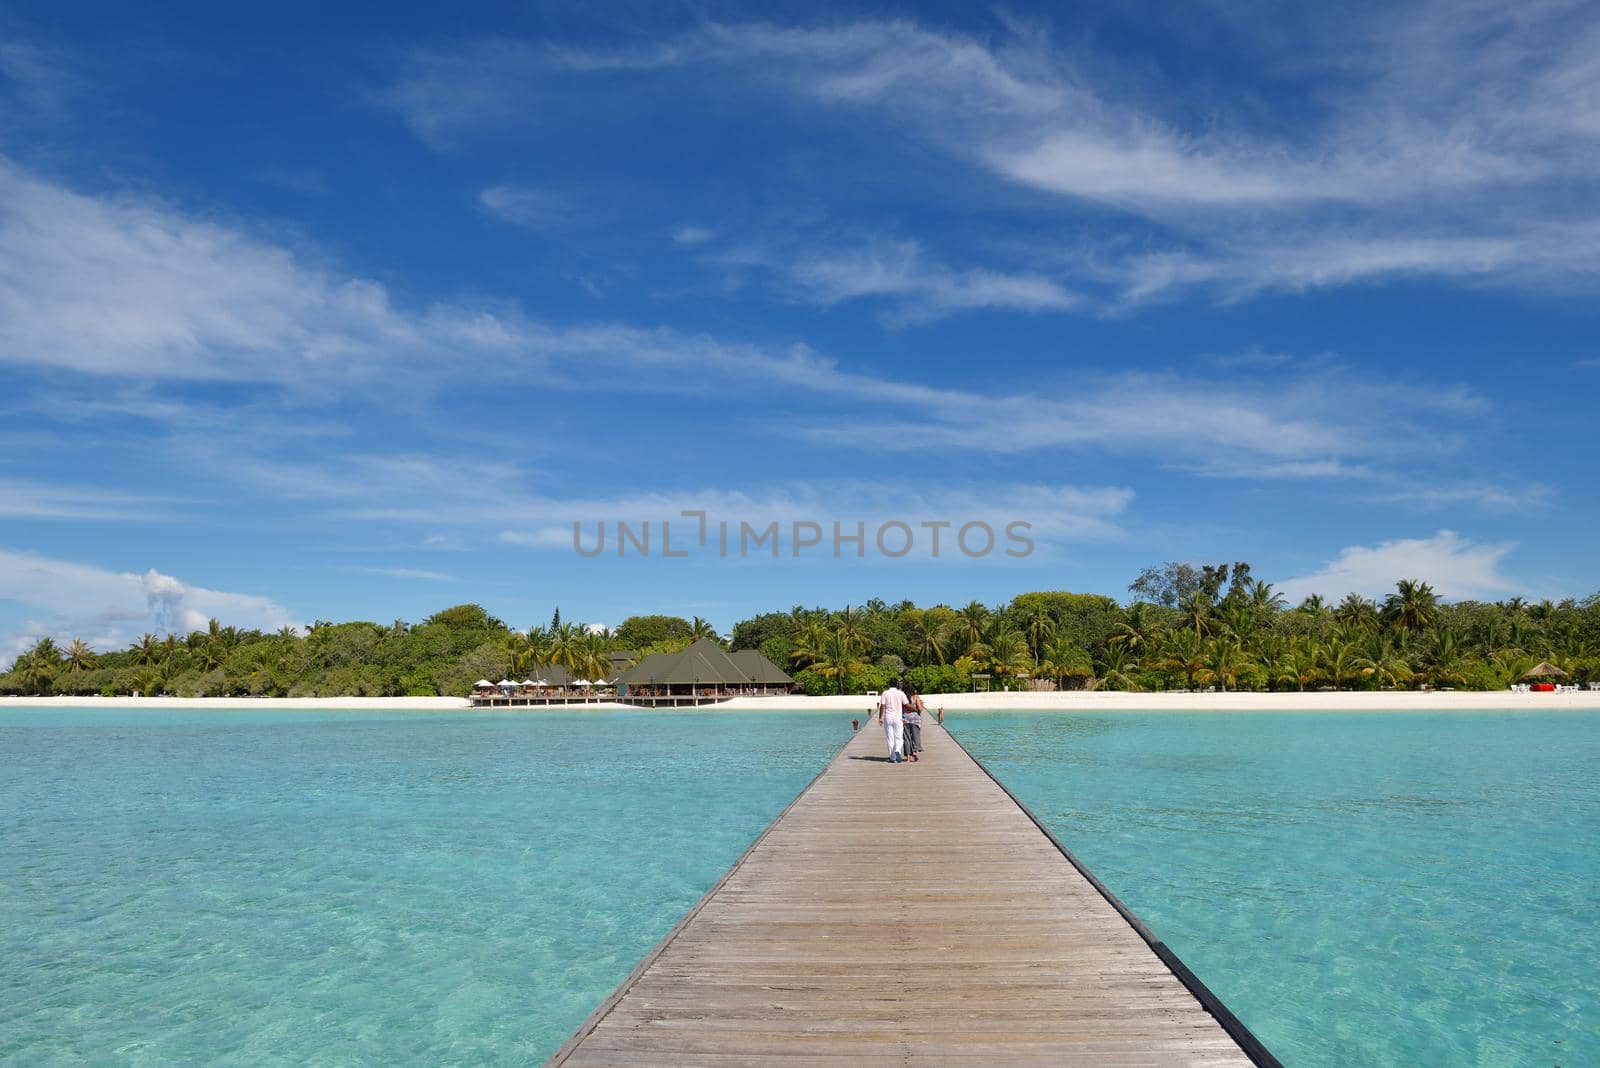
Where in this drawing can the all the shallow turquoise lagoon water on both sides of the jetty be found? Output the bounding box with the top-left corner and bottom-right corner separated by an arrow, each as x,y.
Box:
0,710 -> 1600,1068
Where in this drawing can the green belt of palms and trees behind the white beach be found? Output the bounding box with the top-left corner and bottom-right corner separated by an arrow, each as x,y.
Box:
12,575 -> 1600,697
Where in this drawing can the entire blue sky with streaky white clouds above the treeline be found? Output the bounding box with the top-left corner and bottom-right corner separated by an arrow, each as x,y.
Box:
0,2 -> 1600,648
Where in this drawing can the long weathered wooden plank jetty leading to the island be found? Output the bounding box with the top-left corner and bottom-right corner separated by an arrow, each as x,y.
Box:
549,723 -> 1278,1068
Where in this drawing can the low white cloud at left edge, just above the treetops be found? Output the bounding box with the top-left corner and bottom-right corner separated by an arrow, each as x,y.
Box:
0,550 -> 293,649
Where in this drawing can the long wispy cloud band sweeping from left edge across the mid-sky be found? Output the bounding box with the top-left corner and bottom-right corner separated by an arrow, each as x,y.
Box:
0,156 -> 1486,482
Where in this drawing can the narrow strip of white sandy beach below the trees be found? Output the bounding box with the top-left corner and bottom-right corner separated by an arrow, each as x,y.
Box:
0,691 -> 1600,713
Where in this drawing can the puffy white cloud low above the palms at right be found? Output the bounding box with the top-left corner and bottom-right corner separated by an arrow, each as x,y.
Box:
1278,531 -> 1523,601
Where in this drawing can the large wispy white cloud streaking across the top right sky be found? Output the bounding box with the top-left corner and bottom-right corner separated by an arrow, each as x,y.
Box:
387,9 -> 1600,309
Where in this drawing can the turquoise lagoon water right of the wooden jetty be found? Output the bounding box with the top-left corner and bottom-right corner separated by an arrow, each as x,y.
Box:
947,713 -> 1600,1068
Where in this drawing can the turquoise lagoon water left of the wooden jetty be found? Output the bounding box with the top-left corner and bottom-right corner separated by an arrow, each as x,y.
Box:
0,710 -> 850,1065
